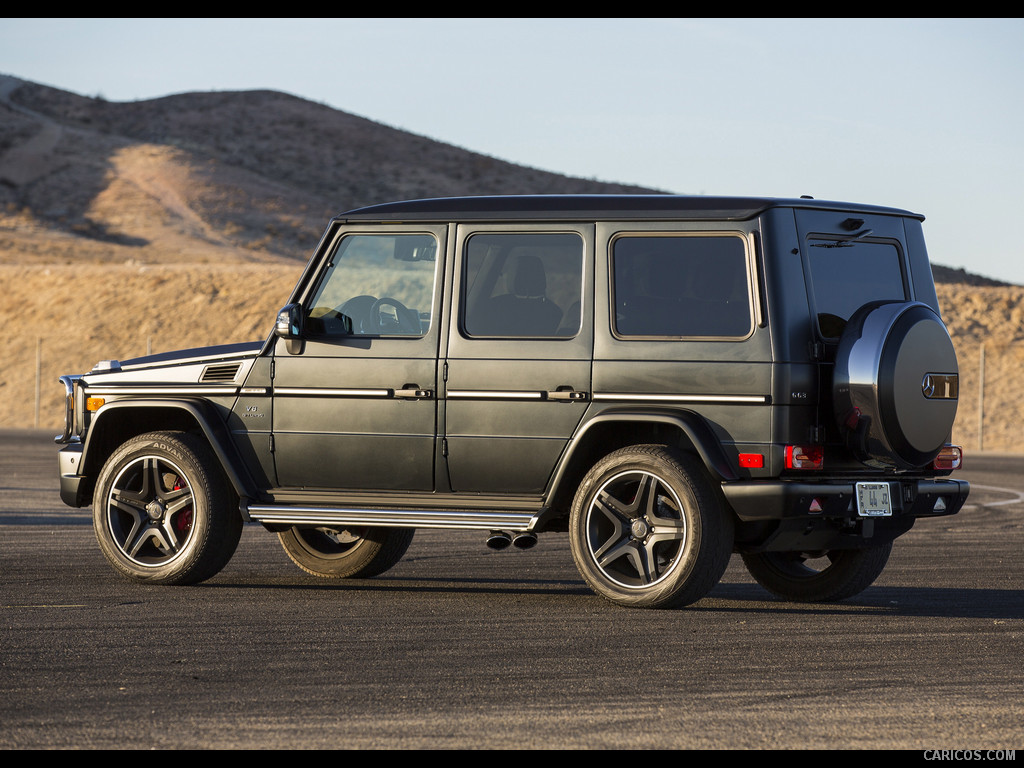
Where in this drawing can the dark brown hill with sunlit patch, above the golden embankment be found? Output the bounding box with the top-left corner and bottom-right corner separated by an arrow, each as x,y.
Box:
0,78 -> 655,263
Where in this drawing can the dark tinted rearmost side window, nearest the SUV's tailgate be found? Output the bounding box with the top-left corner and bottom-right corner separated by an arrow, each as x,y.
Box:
611,234 -> 754,339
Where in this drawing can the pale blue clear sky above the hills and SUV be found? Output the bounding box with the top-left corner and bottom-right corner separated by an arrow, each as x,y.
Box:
0,17 -> 1024,284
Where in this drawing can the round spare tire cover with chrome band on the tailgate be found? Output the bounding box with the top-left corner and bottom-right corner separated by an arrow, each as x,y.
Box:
833,302 -> 959,469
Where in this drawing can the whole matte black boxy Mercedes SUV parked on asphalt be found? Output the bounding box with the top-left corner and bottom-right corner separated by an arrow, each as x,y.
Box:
57,196 -> 968,607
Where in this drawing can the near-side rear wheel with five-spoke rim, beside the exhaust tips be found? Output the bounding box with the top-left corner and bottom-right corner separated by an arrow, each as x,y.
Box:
569,445 -> 733,608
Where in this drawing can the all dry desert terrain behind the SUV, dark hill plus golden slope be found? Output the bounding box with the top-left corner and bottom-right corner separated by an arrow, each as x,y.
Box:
0,76 -> 1024,451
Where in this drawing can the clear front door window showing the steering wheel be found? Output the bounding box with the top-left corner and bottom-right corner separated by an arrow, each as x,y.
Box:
307,234 -> 437,336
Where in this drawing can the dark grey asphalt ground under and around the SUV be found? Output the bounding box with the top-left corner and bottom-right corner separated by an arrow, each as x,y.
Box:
0,430 -> 1024,756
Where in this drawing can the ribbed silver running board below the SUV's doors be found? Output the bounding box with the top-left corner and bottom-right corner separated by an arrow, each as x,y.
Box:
248,504 -> 540,530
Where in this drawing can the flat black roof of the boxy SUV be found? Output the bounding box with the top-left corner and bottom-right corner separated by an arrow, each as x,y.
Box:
336,195 -> 924,221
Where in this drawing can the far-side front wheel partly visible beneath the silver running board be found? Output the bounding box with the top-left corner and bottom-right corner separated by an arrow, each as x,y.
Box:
278,526 -> 416,579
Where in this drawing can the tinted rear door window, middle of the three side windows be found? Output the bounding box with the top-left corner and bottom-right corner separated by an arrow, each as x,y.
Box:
462,233 -> 584,339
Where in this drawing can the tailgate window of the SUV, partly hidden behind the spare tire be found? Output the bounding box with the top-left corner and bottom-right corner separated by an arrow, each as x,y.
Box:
807,239 -> 907,338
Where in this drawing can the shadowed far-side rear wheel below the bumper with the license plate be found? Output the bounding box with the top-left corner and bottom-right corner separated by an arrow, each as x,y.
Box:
742,542 -> 893,603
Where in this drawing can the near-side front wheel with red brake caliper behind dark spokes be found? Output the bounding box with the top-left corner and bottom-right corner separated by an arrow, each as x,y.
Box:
92,432 -> 243,585
